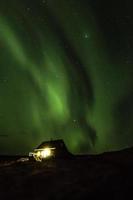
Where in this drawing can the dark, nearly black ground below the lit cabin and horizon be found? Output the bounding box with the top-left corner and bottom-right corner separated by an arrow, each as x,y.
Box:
0,149 -> 133,200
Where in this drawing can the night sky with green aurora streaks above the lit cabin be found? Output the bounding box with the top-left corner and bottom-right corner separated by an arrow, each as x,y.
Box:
0,0 -> 133,154
